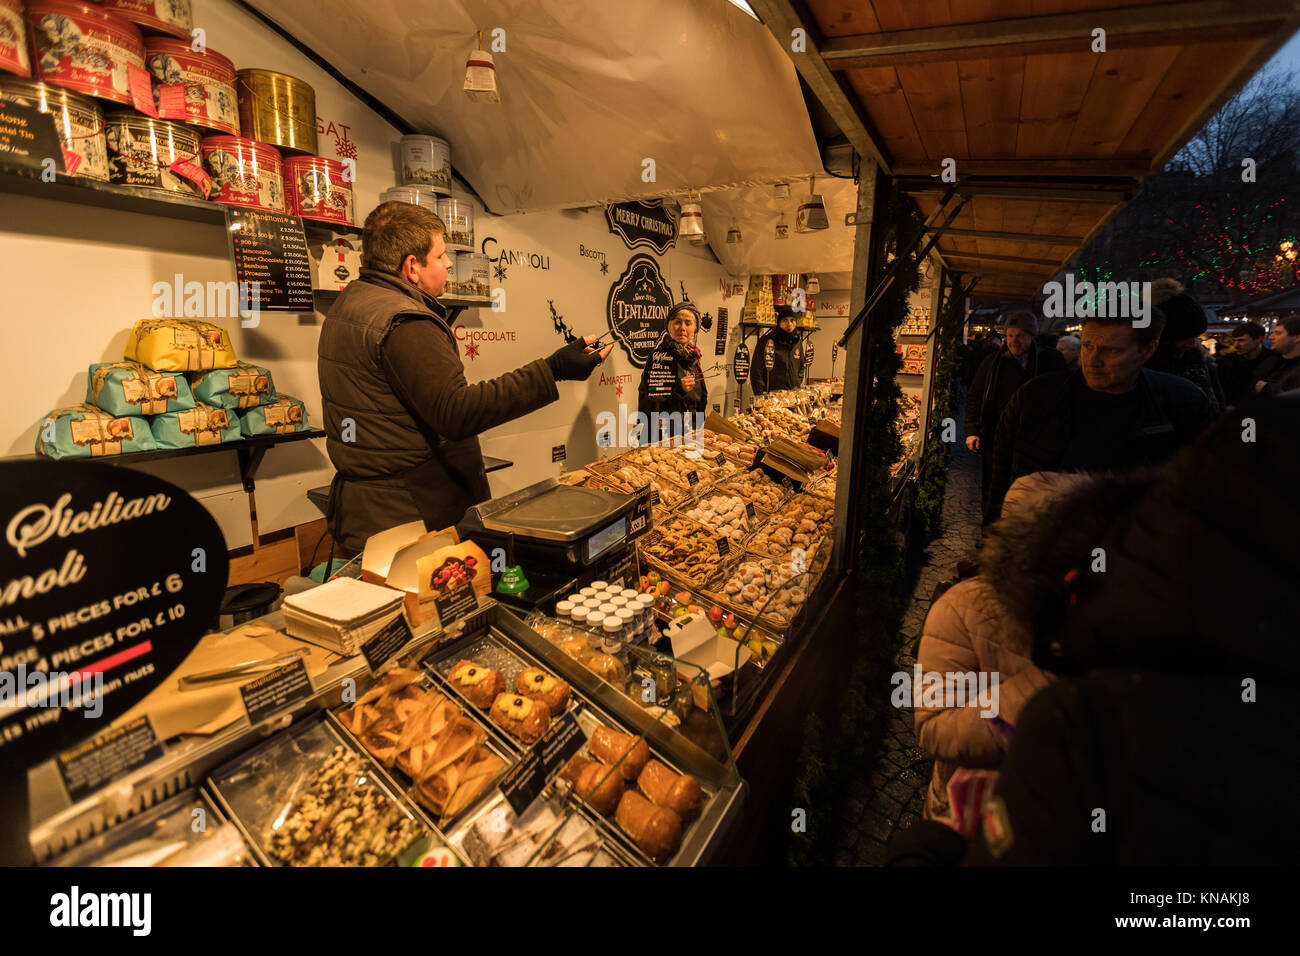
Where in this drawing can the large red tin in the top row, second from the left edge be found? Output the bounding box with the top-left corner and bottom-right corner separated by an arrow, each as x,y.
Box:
27,0 -> 144,104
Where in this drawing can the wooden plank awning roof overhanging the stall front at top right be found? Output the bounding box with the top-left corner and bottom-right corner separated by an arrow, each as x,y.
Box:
751,0 -> 1300,299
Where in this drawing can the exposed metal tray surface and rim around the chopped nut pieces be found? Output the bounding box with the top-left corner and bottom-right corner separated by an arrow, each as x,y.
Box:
207,713 -> 441,866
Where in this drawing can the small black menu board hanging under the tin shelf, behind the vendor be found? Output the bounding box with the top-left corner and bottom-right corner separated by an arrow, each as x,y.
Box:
226,208 -> 315,312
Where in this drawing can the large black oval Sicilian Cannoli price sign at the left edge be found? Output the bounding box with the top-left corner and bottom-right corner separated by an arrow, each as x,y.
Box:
0,460 -> 228,865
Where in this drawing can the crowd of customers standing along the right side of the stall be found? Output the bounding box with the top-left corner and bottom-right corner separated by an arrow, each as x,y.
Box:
892,280 -> 1300,865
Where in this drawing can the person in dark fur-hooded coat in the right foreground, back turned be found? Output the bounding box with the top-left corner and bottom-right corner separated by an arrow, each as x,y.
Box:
966,395 -> 1300,866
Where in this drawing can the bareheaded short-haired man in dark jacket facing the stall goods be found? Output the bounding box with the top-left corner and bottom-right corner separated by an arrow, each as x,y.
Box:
987,308 -> 1212,514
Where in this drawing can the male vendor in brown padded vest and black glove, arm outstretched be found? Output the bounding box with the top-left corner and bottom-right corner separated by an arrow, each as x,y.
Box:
317,203 -> 614,553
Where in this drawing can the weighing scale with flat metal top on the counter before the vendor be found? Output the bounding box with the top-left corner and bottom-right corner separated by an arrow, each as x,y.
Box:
456,479 -> 650,613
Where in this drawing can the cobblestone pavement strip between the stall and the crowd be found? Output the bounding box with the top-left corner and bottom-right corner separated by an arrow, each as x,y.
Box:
835,403 -> 980,866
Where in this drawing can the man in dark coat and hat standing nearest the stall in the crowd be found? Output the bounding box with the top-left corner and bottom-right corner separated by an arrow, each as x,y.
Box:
966,311 -> 1065,524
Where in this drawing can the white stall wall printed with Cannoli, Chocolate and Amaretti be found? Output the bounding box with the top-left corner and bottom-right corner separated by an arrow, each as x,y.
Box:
0,0 -> 753,548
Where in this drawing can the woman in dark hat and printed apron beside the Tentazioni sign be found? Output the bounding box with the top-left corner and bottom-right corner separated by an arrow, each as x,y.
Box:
637,302 -> 709,442
